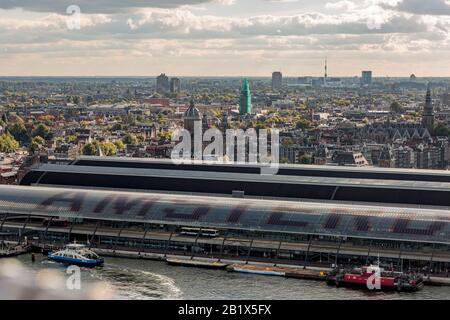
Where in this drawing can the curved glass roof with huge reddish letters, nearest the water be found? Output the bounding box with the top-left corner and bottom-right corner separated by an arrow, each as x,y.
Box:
0,186 -> 450,244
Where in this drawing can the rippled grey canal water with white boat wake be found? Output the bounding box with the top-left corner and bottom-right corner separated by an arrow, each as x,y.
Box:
8,254 -> 450,300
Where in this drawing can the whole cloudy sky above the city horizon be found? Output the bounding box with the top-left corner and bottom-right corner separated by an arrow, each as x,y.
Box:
0,0 -> 450,77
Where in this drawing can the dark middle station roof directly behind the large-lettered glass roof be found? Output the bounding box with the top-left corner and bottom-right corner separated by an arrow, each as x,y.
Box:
21,164 -> 450,207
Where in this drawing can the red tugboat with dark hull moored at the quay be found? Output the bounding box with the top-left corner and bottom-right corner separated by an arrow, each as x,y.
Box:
326,265 -> 424,292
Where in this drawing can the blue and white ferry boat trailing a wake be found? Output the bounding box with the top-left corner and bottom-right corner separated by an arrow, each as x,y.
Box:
48,243 -> 104,267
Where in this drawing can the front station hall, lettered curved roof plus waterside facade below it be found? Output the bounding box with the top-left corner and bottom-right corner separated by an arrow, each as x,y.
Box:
0,179 -> 450,272
